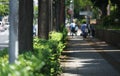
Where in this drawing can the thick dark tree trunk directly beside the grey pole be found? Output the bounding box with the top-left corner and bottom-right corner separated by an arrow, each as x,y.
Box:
19,0 -> 33,53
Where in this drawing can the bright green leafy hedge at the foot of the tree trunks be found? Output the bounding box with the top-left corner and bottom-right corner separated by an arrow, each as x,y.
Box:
0,32 -> 65,76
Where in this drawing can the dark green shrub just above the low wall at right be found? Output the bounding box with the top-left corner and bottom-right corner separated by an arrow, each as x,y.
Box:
97,11 -> 120,30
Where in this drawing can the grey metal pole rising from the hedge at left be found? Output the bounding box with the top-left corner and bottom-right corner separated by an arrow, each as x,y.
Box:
9,0 -> 19,63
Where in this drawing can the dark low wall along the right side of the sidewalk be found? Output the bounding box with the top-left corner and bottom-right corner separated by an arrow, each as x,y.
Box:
95,29 -> 120,48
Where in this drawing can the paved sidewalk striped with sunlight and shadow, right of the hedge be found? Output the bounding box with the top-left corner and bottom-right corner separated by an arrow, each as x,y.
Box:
61,36 -> 120,76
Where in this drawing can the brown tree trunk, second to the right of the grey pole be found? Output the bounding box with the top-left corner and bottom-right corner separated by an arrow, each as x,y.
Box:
38,0 -> 49,39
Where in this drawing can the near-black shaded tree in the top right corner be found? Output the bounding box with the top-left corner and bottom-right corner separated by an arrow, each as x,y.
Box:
91,0 -> 120,18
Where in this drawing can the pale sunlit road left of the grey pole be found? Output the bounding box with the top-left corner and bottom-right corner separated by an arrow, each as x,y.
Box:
0,30 -> 9,50
